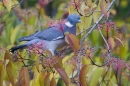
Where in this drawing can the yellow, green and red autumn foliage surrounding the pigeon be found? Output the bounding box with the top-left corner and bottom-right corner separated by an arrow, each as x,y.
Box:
0,0 -> 130,86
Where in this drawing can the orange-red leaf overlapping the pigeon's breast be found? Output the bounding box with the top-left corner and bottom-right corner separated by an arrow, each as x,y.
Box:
65,34 -> 80,52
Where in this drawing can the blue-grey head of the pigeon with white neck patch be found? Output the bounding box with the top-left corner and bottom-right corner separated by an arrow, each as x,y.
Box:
65,14 -> 81,27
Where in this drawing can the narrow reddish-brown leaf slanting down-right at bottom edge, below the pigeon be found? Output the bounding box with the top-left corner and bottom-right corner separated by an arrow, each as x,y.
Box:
56,68 -> 69,86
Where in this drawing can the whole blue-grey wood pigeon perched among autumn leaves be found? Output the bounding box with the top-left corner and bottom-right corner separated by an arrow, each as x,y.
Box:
10,14 -> 81,56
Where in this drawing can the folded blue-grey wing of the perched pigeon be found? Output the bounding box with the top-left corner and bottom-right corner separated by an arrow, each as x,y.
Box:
19,27 -> 64,41
